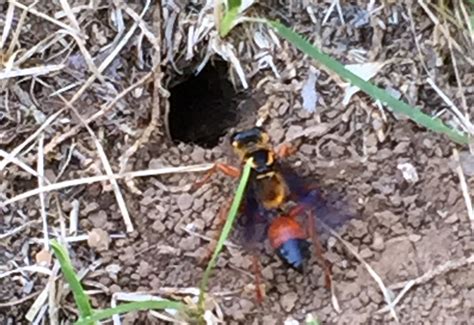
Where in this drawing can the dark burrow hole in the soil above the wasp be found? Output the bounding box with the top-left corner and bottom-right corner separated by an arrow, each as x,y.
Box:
168,60 -> 242,148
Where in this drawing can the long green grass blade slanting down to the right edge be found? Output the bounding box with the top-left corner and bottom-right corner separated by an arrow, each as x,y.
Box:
266,20 -> 469,144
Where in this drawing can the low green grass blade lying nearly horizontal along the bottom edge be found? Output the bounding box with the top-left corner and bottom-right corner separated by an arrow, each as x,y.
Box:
75,300 -> 184,325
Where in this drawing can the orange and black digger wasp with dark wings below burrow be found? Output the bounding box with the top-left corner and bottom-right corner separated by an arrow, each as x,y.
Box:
194,127 -> 347,300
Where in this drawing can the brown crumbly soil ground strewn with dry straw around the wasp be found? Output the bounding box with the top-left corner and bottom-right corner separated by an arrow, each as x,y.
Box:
0,1 -> 474,324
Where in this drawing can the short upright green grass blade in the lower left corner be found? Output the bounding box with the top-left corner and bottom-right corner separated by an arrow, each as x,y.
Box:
51,240 -> 93,318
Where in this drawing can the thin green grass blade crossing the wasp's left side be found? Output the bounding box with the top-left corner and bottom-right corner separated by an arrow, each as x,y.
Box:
198,158 -> 253,315
